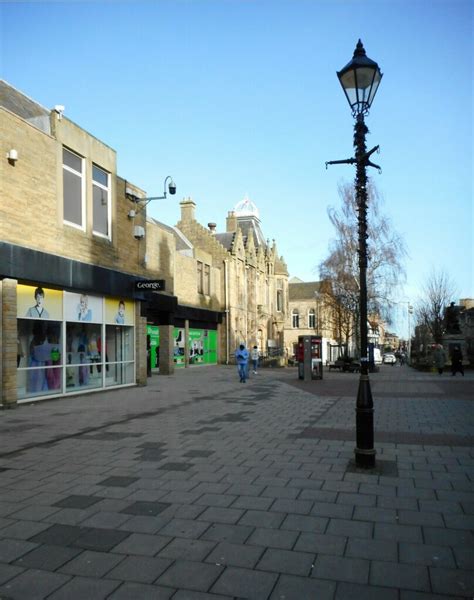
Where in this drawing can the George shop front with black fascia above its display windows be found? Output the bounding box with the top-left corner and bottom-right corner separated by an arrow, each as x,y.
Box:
0,242 -> 181,407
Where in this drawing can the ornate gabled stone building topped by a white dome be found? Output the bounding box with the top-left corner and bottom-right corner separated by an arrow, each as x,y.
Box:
176,198 -> 288,363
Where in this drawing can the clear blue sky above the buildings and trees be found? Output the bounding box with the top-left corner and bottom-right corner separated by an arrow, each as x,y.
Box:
0,0 -> 474,333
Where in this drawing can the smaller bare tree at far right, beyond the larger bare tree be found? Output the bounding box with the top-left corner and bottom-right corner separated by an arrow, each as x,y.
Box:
415,270 -> 456,344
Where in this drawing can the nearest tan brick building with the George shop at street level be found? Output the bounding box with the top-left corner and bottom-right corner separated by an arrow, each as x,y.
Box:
0,81 -> 189,405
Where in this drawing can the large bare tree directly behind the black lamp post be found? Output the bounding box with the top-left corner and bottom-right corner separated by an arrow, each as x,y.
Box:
319,181 -> 406,350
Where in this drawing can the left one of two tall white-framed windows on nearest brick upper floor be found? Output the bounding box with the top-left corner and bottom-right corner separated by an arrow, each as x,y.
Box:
63,148 -> 85,229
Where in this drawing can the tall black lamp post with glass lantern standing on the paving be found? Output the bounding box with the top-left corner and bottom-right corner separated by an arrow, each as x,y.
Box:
326,40 -> 382,469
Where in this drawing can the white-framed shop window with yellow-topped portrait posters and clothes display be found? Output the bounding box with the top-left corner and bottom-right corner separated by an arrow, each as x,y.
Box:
17,284 -> 136,402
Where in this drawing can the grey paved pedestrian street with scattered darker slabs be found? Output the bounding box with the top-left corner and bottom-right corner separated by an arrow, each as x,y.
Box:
0,365 -> 474,600
